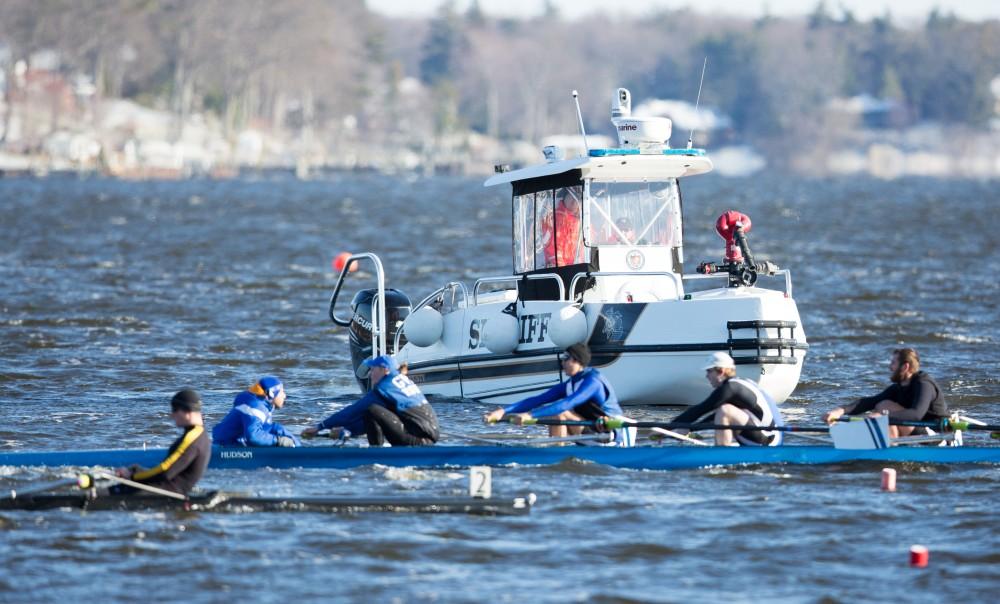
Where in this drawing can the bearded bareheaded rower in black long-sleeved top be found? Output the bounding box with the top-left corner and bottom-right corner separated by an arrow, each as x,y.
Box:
823,348 -> 948,438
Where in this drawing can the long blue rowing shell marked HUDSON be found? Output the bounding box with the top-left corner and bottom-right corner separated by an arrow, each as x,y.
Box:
0,445 -> 1000,470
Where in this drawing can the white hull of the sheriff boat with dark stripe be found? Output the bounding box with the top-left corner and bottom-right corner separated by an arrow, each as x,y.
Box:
399,288 -> 808,405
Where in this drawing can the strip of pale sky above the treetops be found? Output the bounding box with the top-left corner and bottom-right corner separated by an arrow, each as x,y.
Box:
365,0 -> 1000,23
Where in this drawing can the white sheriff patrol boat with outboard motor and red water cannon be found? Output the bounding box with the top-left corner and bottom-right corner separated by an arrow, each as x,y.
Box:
329,88 -> 808,405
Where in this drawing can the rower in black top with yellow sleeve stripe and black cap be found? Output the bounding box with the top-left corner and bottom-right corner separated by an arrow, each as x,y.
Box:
110,390 -> 212,495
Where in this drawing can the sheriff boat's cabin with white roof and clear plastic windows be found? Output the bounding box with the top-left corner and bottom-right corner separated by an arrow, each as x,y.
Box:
486,149 -> 712,301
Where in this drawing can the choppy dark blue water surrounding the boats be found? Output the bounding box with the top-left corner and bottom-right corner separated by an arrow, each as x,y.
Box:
0,172 -> 1000,602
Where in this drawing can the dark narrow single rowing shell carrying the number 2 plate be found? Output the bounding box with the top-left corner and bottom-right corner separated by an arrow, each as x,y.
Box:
0,491 -> 535,515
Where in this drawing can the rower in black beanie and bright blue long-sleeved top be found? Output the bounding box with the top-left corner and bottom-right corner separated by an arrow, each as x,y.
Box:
483,344 -> 635,446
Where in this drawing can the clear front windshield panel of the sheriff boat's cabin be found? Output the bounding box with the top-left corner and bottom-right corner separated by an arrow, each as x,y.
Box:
583,179 -> 681,247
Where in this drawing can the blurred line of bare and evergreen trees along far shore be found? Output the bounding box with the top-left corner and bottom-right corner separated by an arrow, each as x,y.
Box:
0,0 -> 1000,156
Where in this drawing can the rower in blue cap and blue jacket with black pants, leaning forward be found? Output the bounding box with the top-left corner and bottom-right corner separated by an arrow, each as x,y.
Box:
302,355 -> 439,447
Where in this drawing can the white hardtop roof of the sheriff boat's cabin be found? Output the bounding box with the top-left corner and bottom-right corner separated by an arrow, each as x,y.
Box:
483,149 -> 712,187
